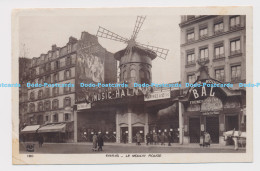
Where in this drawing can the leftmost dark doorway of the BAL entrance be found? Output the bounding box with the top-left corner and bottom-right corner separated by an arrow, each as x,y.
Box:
189,117 -> 200,143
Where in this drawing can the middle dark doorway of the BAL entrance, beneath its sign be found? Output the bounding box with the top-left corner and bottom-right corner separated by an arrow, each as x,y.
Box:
206,116 -> 219,143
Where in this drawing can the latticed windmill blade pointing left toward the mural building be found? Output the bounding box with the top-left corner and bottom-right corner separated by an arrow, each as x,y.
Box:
96,26 -> 128,43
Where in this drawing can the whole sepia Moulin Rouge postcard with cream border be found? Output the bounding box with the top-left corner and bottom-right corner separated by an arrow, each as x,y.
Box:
11,6 -> 254,164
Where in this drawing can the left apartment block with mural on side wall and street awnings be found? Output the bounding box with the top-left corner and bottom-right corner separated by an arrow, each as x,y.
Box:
22,32 -> 116,142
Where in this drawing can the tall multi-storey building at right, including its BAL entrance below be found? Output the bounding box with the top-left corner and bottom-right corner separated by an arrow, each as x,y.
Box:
179,15 -> 246,144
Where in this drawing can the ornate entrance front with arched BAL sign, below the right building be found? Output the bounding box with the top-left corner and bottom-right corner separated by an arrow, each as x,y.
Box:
180,78 -> 245,145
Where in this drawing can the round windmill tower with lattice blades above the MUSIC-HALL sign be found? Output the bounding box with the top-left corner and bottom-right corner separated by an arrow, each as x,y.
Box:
97,16 -> 169,87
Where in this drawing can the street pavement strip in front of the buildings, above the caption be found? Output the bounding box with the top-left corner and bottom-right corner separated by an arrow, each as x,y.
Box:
20,142 -> 246,154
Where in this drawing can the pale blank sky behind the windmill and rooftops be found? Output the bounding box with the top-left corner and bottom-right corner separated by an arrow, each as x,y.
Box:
18,11 -> 180,83
